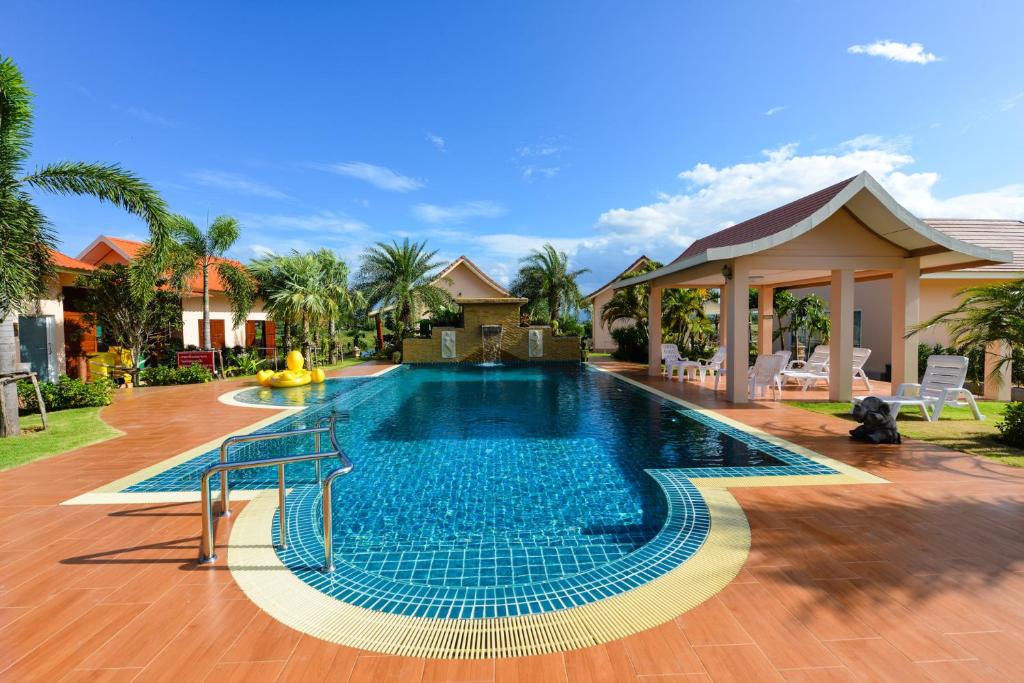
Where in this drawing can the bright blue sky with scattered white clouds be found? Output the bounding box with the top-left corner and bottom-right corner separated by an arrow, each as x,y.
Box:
0,2 -> 1024,289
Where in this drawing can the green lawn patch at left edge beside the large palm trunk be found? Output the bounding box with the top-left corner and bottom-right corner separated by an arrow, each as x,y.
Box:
0,408 -> 123,470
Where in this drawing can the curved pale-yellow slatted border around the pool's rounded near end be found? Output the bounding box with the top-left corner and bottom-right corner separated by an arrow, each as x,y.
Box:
227,488 -> 751,658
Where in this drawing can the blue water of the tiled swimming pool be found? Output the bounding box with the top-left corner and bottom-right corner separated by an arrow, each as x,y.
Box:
129,364 -> 833,616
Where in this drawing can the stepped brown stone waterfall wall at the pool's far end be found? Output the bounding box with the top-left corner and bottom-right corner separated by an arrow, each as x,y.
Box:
401,297 -> 581,365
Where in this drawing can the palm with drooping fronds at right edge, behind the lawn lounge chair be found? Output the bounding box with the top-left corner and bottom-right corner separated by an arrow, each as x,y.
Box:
908,280 -> 1024,379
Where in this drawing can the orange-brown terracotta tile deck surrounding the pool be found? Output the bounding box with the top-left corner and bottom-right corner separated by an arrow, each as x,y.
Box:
0,362 -> 1024,683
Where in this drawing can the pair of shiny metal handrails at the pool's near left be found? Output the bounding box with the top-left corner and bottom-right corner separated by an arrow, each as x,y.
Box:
199,414 -> 353,571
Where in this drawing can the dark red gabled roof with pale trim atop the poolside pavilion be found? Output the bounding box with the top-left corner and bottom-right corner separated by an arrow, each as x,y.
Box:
614,171 -> 1012,289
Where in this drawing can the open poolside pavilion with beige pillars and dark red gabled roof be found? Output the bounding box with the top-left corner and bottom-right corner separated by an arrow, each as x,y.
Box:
614,171 -> 1012,403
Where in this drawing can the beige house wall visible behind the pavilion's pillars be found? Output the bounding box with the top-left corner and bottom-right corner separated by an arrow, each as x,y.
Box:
790,275 -> 996,376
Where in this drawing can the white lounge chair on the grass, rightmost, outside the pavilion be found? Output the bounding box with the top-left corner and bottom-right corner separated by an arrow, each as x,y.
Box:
853,355 -> 985,422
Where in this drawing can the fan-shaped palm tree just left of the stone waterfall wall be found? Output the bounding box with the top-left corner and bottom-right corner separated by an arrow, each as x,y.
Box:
355,238 -> 452,342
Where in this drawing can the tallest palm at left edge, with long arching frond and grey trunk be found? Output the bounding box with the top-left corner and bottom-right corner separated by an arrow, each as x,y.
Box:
0,57 -> 169,436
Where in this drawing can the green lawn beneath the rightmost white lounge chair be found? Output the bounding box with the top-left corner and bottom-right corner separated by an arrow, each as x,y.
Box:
786,400 -> 1024,467
